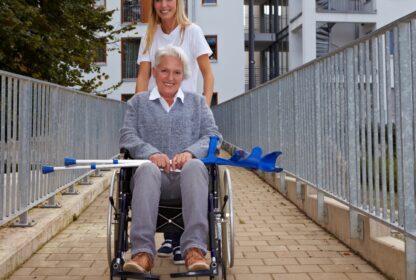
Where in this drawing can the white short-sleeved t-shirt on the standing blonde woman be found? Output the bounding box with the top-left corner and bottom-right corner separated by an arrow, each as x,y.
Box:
137,23 -> 212,93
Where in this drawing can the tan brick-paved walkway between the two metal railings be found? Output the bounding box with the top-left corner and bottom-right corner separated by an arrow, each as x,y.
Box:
10,168 -> 386,280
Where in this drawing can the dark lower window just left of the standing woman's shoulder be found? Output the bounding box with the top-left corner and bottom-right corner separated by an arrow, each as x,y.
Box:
121,38 -> 140,79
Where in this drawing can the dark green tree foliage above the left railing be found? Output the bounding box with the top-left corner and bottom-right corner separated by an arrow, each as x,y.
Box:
0,0 -> 130,92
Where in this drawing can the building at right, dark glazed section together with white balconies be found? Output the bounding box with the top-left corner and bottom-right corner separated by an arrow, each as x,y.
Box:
244,0 -> 416,89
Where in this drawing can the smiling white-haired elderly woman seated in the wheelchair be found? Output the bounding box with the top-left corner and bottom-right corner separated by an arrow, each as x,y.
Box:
112,45 -> 231,279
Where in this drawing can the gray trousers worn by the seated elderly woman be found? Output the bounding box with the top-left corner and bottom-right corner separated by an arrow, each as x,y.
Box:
130,159 -> 208,258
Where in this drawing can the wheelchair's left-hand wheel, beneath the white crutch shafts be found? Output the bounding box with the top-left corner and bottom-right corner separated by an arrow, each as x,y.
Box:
107,170 -> 119,268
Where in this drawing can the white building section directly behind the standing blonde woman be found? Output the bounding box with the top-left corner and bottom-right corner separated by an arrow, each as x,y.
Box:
92,0 -> 245,103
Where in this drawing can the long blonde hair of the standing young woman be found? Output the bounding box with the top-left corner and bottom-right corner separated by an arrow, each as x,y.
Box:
143,0 -> 191,53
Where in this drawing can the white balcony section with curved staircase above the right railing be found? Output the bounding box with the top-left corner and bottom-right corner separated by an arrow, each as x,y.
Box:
288,0 -> 416,70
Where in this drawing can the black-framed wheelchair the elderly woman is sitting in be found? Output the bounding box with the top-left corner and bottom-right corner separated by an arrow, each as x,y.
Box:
107,156 -> 234,280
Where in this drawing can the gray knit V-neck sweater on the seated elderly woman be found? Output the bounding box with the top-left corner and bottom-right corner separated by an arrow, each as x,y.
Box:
120,92 -> 222,159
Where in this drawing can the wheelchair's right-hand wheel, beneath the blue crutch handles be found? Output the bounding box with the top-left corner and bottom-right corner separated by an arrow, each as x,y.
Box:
220,169 -> 234,273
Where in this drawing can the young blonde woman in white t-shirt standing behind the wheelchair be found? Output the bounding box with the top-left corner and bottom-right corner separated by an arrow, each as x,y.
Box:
136,0 -> 214,264
